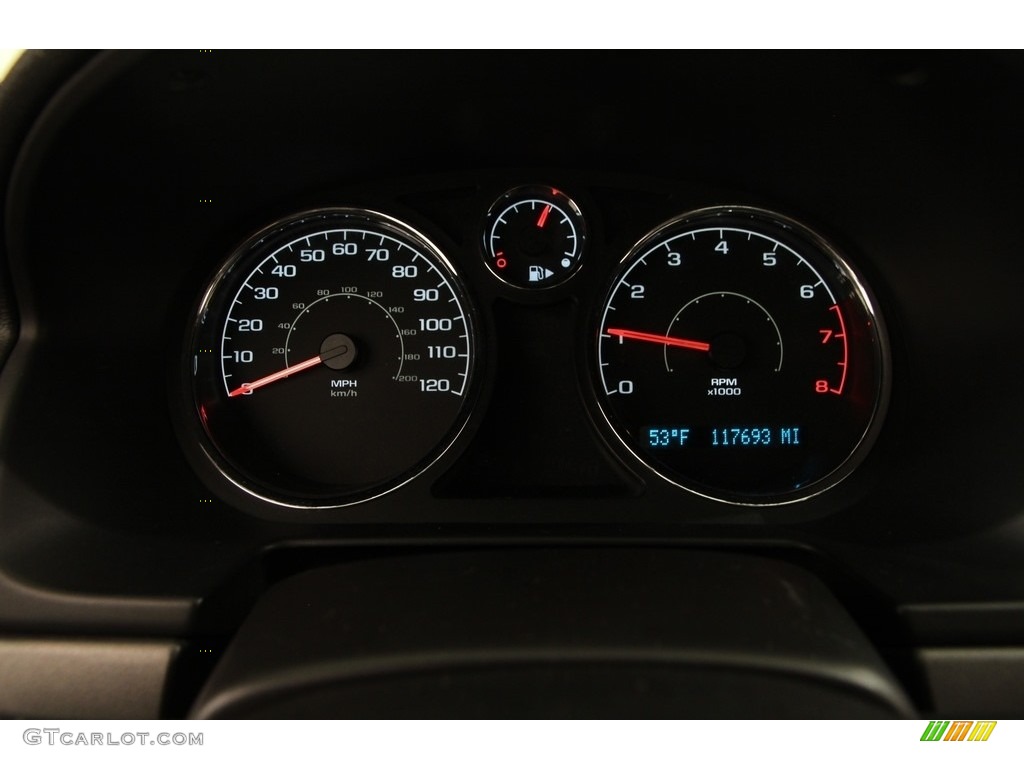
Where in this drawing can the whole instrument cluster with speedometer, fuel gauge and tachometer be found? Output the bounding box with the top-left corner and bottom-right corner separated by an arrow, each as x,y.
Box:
178,179 -> 890,521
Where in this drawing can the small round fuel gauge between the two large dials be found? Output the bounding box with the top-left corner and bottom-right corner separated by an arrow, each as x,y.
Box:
483,184 -> 587,289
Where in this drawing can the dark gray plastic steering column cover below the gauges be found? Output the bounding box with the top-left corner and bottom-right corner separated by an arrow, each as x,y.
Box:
193,548 -> 913,718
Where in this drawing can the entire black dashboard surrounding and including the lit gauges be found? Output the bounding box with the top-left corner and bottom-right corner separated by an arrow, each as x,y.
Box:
0,50 -> 1024,717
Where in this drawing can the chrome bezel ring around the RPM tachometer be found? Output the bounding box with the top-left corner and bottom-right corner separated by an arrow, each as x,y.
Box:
587,205 -> 892,508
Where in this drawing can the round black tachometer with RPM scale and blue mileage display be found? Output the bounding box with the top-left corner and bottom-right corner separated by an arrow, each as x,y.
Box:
596,208 -> 888,505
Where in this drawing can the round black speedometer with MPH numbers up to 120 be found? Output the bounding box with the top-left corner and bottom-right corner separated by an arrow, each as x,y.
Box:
188,209 -> 475,507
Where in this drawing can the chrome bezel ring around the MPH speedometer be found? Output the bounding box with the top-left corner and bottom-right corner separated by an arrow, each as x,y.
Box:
181,206 -> 483,514
